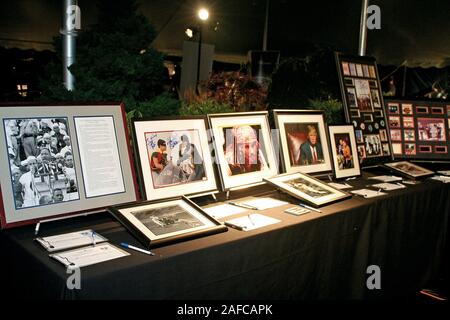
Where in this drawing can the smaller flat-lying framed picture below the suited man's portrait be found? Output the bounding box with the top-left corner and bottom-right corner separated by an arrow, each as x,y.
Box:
264,172 -> 351,207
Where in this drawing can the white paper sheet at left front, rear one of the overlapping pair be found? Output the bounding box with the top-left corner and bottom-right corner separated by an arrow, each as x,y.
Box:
36,229 -> 107,252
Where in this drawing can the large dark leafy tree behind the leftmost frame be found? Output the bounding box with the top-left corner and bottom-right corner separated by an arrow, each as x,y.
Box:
41,0 -> 169,114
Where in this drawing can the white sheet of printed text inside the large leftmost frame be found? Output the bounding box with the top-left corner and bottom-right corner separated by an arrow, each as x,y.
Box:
75,117 -> 125,198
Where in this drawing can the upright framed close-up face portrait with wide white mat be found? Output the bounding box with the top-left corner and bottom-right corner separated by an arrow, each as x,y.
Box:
208,111 -> 278,191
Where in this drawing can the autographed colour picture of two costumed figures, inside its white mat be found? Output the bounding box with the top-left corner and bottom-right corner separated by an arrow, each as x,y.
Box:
145,130 -> 207,189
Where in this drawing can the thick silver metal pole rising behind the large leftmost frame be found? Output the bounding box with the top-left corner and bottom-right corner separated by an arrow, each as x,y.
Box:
60,0 -> 80,91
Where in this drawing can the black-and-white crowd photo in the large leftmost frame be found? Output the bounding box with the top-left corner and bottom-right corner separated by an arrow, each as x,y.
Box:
3,118 -> 80,209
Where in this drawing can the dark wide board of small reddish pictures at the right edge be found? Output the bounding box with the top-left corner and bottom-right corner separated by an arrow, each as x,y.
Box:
386,101 -> 450,159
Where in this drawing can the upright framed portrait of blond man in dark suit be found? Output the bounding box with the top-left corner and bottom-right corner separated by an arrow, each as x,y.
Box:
273,110 -> 332,173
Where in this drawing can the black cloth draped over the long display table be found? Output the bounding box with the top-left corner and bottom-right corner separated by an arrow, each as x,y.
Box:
0,173 -> 450,299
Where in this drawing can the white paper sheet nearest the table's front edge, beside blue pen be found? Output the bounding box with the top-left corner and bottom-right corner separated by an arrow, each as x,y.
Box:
50,243 -> 130,268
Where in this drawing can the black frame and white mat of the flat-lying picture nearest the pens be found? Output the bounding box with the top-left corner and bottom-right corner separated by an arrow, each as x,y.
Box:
107,196 -> 228,248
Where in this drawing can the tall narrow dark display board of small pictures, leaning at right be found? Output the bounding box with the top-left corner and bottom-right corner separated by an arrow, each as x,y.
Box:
335,53 -> 392,167
